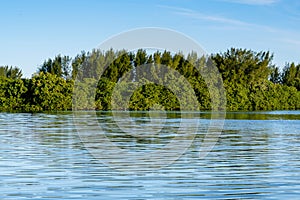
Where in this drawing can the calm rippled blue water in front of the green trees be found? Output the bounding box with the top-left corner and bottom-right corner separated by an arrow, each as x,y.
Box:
0,111 -> 300,199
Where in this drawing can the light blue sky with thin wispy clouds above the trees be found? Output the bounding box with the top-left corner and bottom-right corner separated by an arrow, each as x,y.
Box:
0,0 -> 300,78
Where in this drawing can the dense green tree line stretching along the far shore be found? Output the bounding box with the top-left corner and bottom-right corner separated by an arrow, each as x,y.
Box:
0,48 -> 300,112
